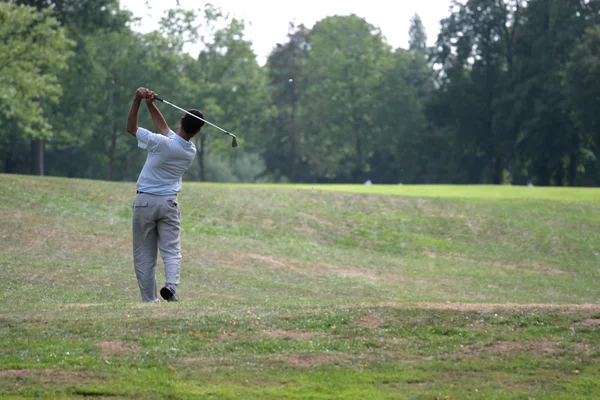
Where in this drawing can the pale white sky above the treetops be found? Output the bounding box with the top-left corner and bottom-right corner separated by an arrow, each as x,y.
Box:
121,0 -> 451,64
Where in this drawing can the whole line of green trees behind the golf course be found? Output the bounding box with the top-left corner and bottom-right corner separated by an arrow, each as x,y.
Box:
0,0 -> 600,186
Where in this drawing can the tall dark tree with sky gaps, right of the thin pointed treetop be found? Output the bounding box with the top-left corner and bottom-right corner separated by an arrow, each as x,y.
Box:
432,0 -> 523,183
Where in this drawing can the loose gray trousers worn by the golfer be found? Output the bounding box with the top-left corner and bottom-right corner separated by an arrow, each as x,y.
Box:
132,193 -> 181,302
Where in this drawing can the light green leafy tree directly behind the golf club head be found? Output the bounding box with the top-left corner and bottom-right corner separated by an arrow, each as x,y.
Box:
181,9 -> 268,180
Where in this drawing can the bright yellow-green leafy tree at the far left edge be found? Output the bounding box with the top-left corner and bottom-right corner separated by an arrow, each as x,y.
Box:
0,3 -> 73,174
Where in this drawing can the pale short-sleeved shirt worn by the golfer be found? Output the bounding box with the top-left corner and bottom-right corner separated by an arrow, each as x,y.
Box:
135,127 -> 196,196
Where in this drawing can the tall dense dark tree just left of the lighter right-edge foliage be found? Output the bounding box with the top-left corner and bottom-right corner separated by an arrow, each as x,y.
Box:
515,0 -> 598,185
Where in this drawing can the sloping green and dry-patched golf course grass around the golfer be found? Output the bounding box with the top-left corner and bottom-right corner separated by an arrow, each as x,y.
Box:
0,175 -> 600,399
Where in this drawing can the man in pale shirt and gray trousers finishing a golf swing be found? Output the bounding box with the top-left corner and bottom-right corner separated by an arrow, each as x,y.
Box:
127,88 -> 204,302
